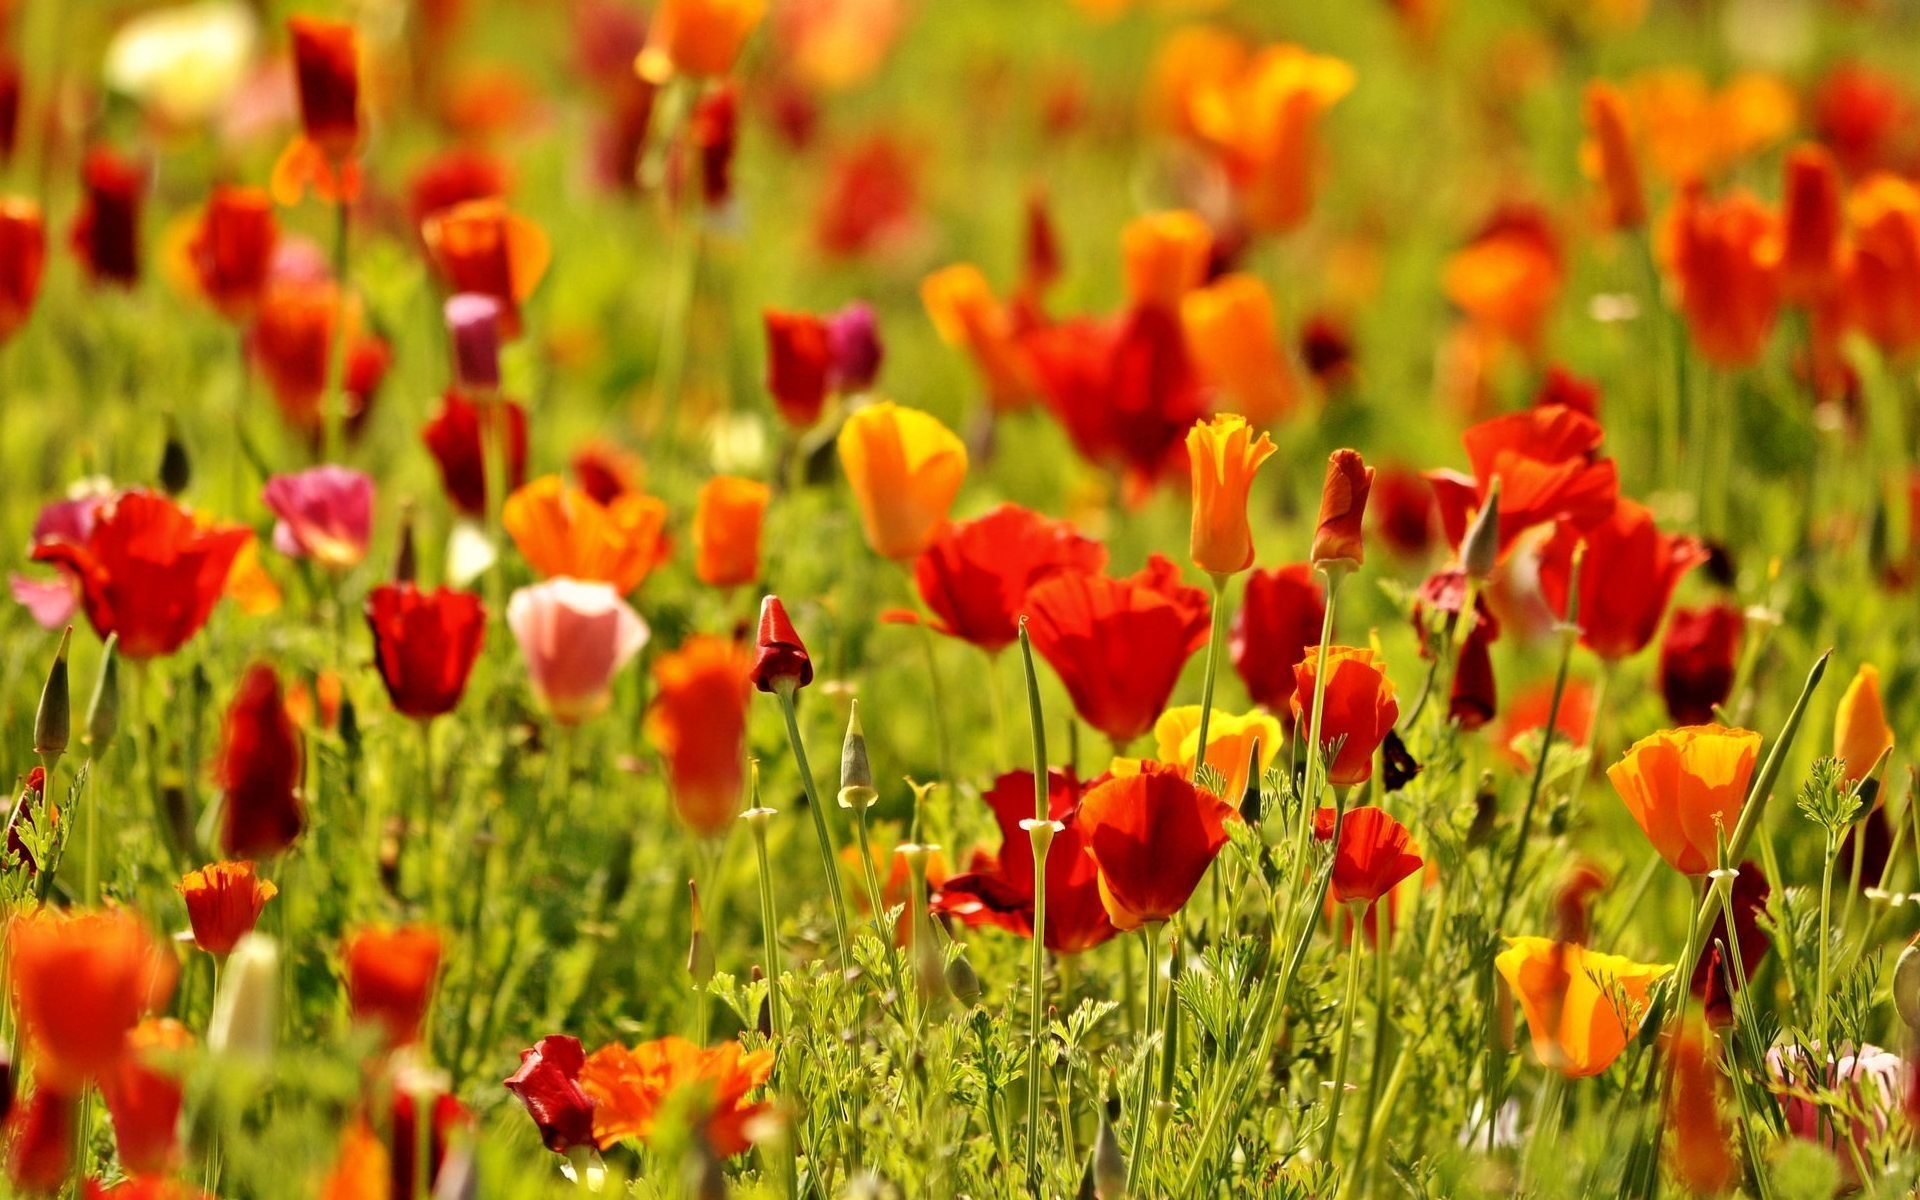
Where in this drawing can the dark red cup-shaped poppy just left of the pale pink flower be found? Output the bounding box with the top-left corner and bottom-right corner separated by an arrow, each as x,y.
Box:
367,584 -> 486,720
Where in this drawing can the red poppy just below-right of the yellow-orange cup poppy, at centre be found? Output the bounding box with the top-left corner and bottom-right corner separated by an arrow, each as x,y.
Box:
914,503 -> 1106,655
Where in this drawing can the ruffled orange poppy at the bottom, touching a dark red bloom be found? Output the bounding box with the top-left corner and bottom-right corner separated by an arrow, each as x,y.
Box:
580,1037 -> 774,1158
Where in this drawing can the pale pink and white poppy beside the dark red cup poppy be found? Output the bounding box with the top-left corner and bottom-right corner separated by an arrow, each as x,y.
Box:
507,576 -> 649,726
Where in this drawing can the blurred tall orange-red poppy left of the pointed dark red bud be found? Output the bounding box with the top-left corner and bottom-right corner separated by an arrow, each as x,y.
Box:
647,634 -> 753,837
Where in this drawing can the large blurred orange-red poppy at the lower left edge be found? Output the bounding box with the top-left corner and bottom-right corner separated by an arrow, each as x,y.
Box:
8,908 -> 175,1089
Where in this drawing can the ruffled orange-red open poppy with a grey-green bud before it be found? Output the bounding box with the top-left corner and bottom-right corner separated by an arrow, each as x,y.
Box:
1427,405 -> 1620,553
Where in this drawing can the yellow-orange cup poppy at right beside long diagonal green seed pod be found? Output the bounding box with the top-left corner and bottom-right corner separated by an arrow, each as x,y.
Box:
1607,726 -> 1761,876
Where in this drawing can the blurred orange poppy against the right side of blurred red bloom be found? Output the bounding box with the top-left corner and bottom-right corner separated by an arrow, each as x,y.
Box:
1181,275 -> 1294,424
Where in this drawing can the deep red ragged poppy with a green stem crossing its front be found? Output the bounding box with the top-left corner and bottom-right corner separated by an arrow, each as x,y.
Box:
931,770 -> 1119,954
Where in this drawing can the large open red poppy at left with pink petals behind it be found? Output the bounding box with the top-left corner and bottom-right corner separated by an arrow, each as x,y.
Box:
33,490 -> 253,659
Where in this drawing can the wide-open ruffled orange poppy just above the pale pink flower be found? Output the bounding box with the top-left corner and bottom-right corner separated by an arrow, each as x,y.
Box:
499,474 -> 668,595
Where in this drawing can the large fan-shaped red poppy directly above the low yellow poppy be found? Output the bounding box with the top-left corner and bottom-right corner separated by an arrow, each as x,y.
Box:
1025,555 -> 1210,747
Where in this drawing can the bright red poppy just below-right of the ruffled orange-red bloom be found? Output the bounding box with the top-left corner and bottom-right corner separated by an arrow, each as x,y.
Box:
1536,495 -> 1707,659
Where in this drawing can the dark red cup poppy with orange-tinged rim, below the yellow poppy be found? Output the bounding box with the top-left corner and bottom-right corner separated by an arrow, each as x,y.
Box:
1075,762 -> 1240,929
